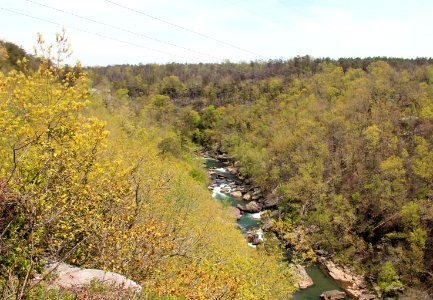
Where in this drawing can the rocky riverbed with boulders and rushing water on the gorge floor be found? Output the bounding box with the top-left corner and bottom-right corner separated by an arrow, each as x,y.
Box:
204,153 -> 378,300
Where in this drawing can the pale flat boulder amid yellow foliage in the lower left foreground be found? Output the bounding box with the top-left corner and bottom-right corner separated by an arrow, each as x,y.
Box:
45,263 -> 141,292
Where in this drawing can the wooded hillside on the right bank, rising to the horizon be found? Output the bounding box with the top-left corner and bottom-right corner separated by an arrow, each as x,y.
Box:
90,56 -> 433,295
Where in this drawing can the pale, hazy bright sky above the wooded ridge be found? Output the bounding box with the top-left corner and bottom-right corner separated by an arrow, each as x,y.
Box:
0,0 -> 433,66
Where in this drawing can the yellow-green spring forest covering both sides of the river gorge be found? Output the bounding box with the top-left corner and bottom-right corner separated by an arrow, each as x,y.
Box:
0,35 -> 433,299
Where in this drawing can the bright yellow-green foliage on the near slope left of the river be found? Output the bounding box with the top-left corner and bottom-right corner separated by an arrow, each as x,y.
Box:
0,34 -> 294,299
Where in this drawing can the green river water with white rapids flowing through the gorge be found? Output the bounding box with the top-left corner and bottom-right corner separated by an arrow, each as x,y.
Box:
205,158 -> 349,300
